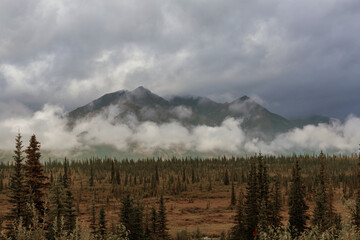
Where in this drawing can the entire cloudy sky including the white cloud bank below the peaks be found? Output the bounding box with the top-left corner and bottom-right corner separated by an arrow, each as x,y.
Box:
0,0 -> 360,155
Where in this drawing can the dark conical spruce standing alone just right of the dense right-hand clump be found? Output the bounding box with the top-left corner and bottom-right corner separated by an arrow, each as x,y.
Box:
289,160 -> 309,238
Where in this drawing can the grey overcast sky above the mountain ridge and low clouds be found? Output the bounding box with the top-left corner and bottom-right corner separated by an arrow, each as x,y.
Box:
0,0 -> 360,118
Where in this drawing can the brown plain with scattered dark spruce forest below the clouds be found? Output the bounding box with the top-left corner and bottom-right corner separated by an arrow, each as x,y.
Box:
0,134 -> 360,240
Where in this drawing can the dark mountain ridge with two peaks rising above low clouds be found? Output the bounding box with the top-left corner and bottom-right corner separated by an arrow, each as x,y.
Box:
68,87 -> 310,140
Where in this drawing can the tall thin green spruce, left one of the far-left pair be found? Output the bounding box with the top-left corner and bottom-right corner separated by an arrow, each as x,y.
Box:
7,133 -> 29,229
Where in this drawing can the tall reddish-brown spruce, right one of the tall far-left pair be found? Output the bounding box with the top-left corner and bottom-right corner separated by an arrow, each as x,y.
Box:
25,135 -> 49,218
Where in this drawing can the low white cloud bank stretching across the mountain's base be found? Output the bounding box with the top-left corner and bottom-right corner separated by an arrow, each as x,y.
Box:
0,105 -> 360,156
